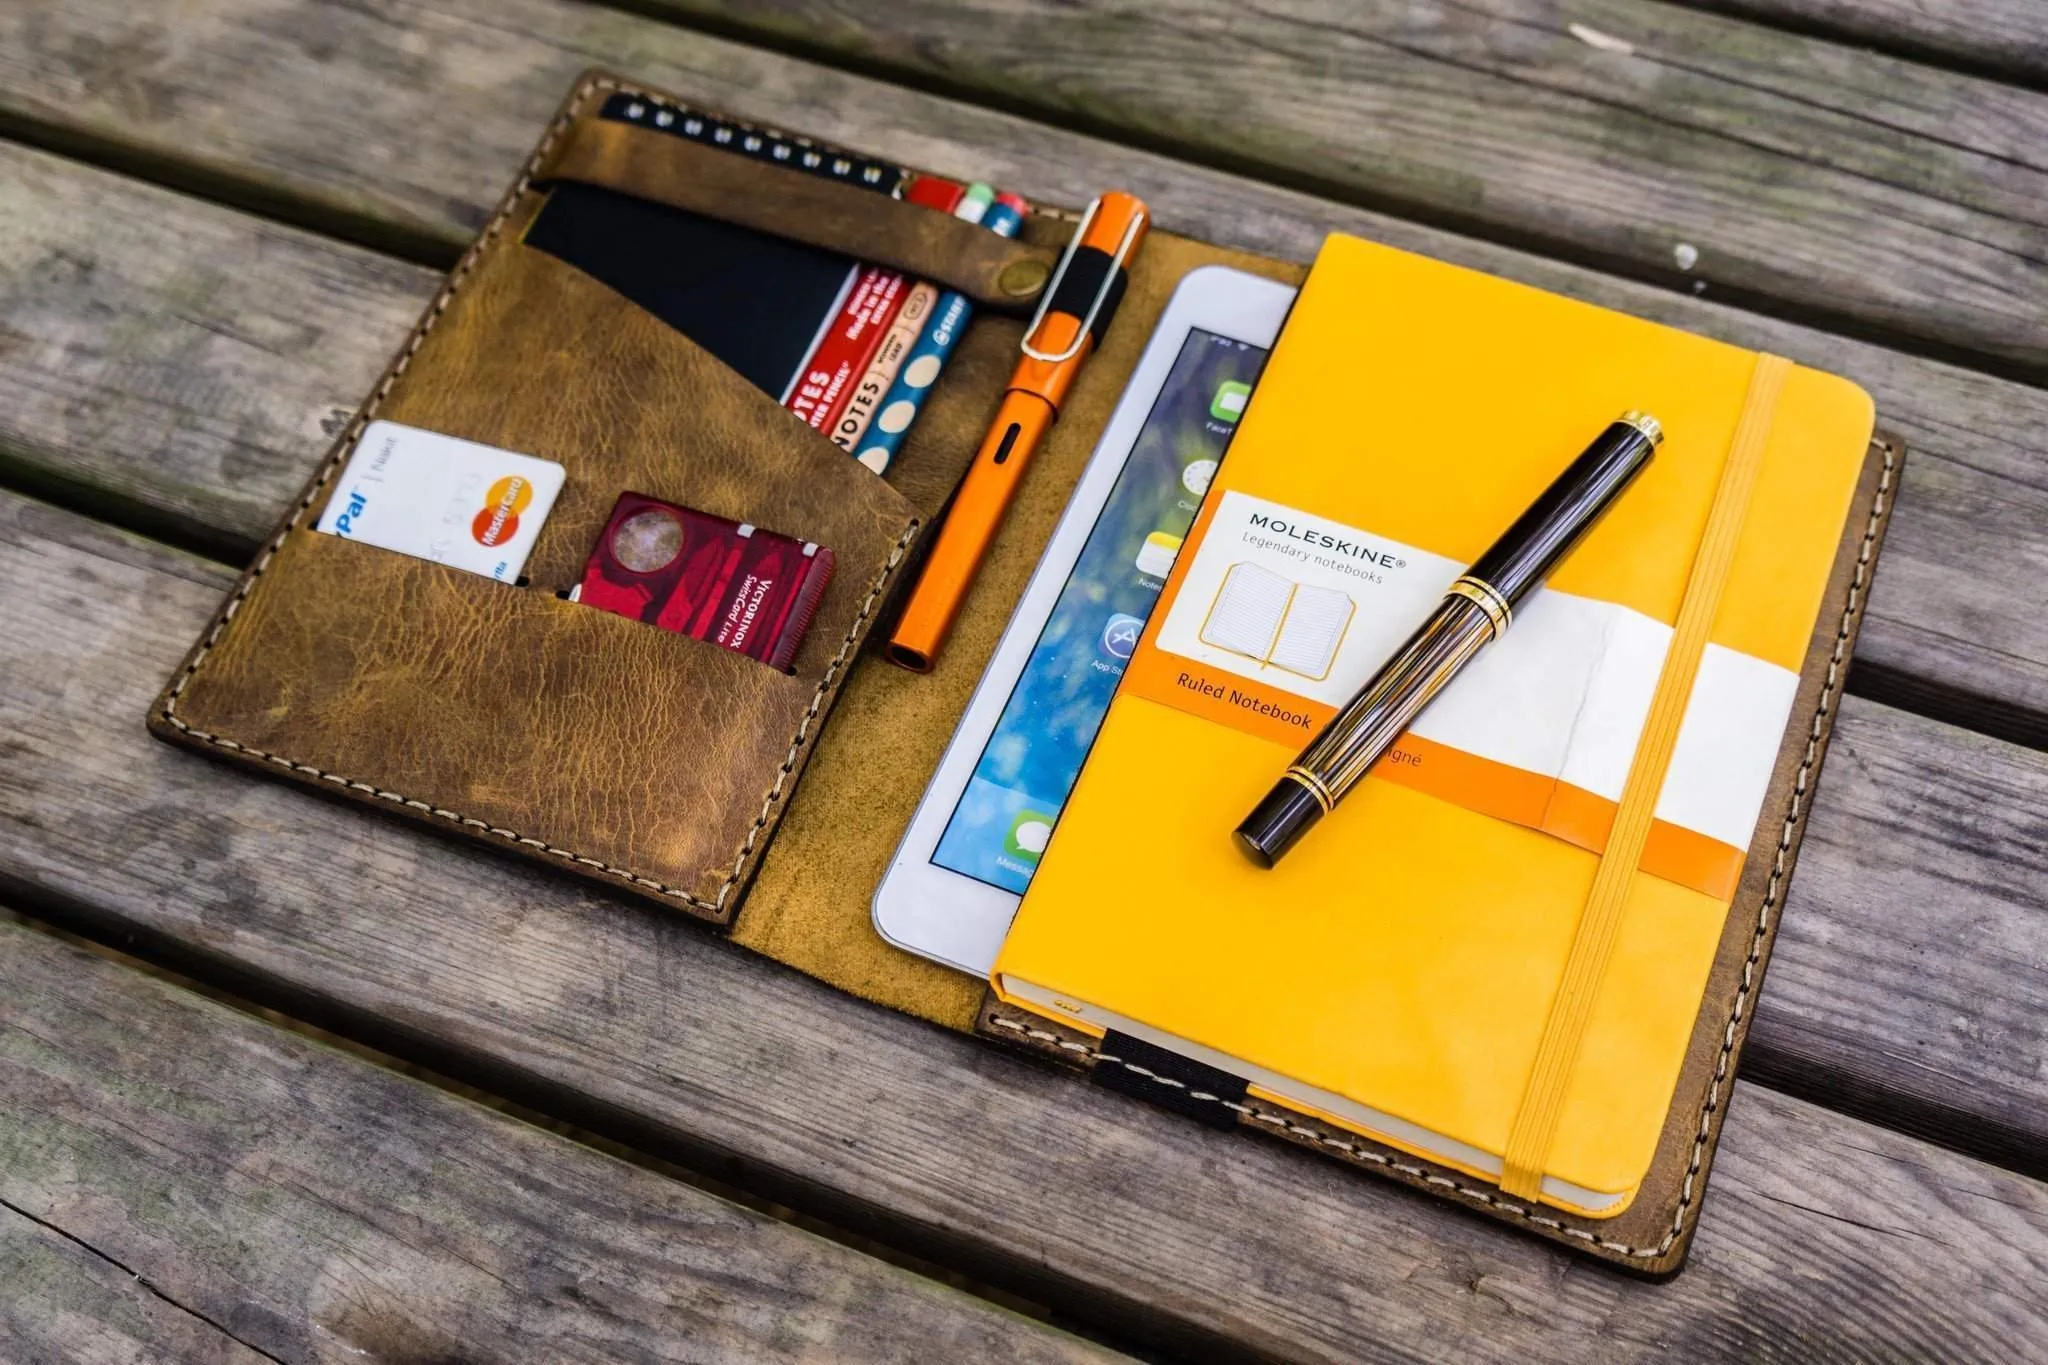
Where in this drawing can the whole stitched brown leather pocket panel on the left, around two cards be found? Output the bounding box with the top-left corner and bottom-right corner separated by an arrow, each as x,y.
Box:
150,196 -> 920,923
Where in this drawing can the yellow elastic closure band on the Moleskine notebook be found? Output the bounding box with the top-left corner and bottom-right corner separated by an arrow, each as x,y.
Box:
1501,354 -> 1792,1199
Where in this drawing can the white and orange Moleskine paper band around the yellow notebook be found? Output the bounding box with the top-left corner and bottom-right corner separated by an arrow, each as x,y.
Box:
1124,491 -> 1798,900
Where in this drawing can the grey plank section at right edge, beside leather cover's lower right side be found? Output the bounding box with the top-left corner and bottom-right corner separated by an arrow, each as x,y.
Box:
1749,698 -> 2048,1179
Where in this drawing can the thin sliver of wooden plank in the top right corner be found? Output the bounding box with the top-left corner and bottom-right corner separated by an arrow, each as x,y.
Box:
1692,0 -> 2048,90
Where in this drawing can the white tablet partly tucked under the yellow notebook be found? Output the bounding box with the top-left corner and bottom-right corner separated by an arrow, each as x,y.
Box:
874,266 -> 1294,976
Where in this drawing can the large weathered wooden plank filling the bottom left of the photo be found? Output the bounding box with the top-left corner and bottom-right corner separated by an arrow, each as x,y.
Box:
0,923 -> 1120,1361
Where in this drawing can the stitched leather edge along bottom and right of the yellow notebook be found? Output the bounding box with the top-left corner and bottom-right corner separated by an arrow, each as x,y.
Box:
989,442 -> 1898,1261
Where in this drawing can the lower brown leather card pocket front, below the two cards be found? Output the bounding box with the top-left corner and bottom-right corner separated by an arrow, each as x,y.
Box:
151,528 -> 839,917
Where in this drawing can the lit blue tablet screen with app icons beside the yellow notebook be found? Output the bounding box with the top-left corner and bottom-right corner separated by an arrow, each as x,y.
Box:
932,327 -> 1266,894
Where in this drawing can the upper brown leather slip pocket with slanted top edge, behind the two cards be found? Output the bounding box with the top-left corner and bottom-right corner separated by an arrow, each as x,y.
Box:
362,244 -> 915,679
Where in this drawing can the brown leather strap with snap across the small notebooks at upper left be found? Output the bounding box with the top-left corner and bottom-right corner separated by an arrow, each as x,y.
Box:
535,117 -> 1055,311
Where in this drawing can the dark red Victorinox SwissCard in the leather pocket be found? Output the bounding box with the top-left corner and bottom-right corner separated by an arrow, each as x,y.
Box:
573,493 -> 831,671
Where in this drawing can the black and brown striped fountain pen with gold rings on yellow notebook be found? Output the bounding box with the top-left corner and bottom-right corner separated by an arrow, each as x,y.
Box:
1237,411 -> 1663,868
